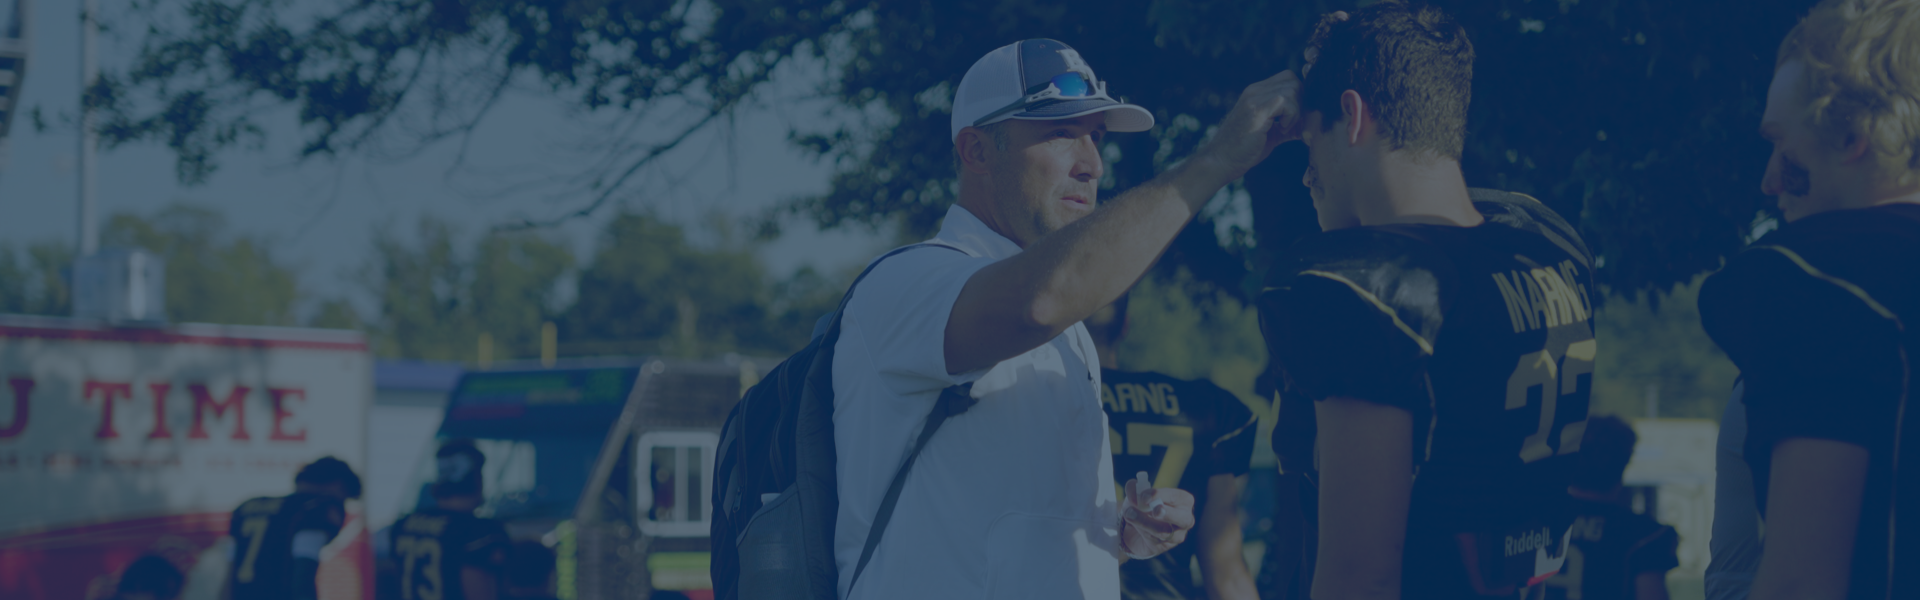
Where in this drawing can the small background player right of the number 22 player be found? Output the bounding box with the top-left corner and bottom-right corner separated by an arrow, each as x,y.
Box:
1548,415 -> 1680,600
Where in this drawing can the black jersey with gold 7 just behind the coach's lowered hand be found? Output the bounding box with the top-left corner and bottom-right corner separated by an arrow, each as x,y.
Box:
1100,369 -> 1258,600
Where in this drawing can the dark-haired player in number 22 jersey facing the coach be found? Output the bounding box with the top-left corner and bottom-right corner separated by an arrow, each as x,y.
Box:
1260,2 -> 1596,598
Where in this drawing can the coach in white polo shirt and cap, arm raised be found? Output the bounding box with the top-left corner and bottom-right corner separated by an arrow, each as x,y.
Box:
833,38 -> 1298,598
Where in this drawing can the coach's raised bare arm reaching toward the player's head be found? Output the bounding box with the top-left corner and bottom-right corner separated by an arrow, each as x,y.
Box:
945,71 -> 1300,373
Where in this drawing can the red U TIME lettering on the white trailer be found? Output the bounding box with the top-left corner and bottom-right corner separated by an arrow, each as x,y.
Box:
0,377 -> 307,442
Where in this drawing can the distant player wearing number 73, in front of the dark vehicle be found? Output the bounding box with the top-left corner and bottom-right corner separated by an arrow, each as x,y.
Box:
390,440 -> 511,600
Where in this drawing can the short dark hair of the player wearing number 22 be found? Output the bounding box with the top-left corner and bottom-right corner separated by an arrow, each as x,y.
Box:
1300,0 -> 1473,160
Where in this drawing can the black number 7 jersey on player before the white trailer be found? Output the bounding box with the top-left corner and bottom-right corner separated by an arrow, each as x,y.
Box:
227,494 -> 346,600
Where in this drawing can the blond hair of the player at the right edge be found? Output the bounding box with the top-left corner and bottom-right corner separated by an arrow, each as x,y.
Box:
1774,0 -> 1920,183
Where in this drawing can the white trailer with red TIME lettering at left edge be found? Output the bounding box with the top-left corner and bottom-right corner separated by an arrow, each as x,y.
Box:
0,315 -> 372,600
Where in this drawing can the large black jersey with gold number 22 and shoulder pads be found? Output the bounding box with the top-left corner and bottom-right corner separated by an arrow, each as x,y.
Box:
1260,188 -> 1596,598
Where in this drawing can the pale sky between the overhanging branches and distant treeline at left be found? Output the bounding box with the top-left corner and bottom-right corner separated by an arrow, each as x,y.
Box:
0,0 -> 891,319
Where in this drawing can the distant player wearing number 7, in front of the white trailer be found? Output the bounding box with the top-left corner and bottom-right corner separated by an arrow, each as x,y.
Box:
223,456 -> 361,600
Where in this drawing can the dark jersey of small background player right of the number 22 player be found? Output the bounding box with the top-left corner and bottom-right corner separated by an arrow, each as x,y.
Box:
1548,498 -> 1680,600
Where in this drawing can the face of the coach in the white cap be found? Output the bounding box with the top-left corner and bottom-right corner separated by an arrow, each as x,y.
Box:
987,113 -> 1106,248
